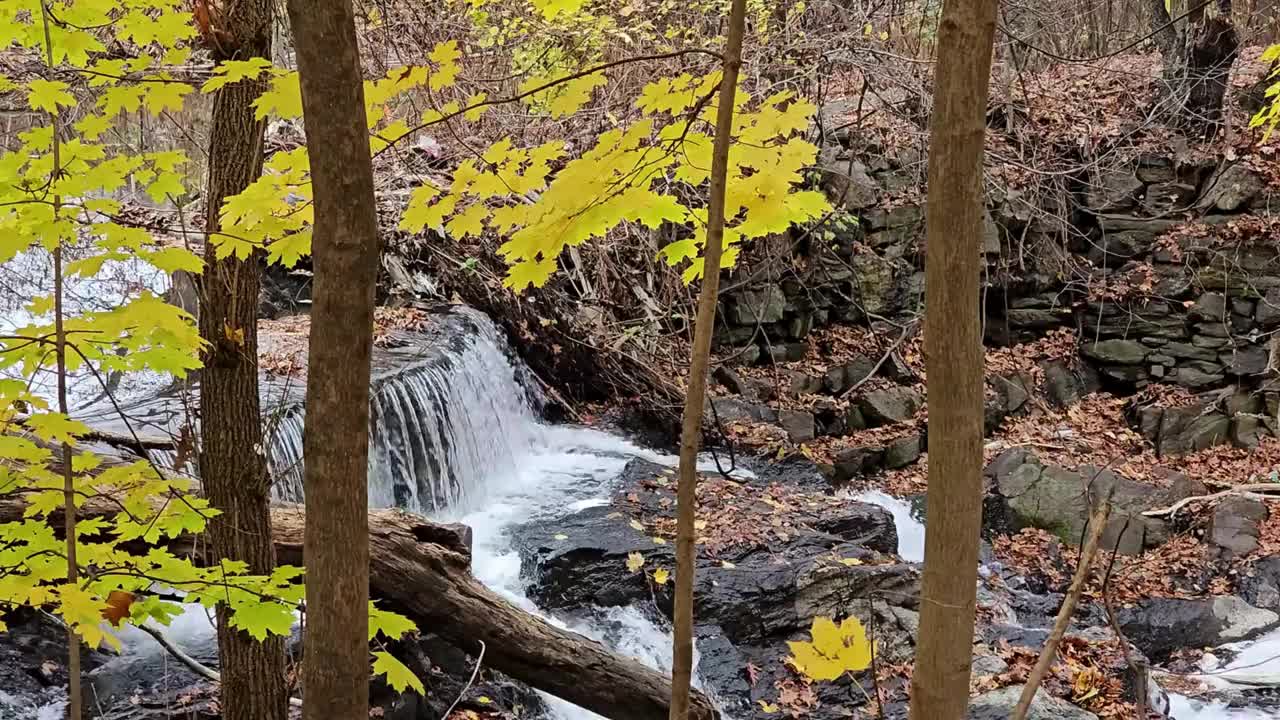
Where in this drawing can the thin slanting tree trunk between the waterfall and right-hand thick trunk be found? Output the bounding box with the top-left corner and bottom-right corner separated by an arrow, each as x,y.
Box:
669,0 -> 746,720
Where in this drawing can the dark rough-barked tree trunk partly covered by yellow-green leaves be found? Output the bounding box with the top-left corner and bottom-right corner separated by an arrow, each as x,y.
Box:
200,0 -> 288,720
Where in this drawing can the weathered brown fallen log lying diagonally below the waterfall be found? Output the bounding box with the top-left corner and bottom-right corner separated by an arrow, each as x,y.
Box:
0,496 -> 717,720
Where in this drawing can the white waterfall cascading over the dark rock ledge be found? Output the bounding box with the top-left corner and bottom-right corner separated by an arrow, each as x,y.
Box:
268,307 -> 543,514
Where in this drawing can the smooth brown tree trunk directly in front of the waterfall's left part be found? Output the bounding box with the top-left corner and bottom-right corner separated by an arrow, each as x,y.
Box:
280,0 -> 378,720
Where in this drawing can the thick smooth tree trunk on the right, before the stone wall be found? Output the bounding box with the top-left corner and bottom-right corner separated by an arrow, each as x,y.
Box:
911,0 -> 998,720
